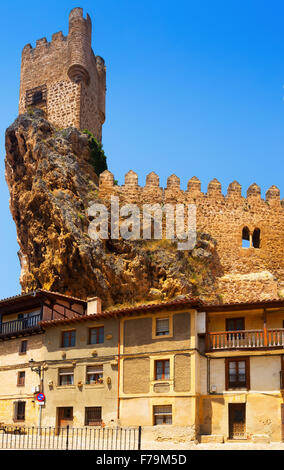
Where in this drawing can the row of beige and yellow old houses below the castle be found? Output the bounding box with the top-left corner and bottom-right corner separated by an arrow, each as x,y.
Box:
0,291 -> 284,442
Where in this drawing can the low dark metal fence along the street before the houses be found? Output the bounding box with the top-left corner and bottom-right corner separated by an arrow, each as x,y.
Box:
0,426 -> 141,450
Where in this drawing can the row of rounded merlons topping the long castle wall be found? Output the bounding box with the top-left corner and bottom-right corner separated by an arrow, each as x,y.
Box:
99,170 -> 284,208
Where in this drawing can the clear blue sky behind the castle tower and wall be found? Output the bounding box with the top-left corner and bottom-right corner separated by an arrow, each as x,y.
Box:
0,0 -> 284,298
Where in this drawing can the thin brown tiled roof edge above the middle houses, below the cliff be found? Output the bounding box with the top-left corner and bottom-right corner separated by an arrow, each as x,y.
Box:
40,298 -> 202,327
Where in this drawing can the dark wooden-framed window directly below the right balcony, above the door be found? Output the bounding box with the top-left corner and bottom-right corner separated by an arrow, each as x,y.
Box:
226,358 -> 250,390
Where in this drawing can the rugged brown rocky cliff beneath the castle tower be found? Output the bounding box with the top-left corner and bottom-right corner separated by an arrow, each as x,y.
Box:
5,110 -> 220,307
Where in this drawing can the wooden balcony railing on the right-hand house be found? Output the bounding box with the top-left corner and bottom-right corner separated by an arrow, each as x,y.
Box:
207,328 -> 284,351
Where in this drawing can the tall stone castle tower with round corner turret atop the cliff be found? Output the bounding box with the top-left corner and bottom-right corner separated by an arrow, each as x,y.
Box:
19,8 -> 106,141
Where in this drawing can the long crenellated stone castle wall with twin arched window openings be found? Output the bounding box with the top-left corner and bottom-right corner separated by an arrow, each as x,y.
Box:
99,171 -> 284,302
